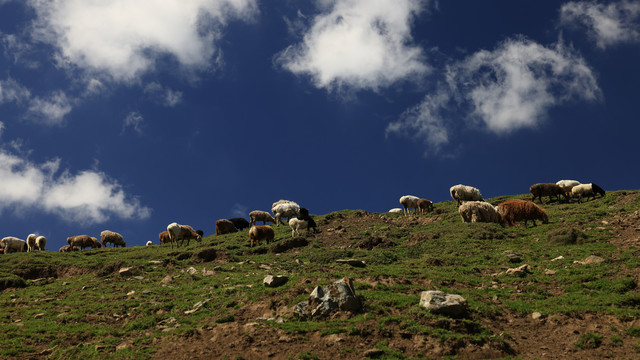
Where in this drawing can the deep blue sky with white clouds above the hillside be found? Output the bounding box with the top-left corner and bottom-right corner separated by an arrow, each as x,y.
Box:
0,0 -> 640,250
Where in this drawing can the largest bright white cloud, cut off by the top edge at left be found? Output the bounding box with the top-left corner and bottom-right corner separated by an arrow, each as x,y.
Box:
29,0 -> 257,81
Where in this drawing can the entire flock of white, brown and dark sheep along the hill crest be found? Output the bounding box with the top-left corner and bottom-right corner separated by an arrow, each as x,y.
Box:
0,180 -> 605,253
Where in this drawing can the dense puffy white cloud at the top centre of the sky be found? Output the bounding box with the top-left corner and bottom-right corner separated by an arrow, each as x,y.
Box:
275,0 -> 429,90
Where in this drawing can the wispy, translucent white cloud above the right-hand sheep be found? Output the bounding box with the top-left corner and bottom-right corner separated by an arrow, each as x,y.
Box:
387,38 -> 601,152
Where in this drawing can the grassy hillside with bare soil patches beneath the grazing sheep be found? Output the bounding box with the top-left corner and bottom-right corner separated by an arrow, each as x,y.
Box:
0,191 -> 640,359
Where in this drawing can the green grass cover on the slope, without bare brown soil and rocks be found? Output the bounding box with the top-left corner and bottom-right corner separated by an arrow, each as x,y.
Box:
0,191 -> 640,359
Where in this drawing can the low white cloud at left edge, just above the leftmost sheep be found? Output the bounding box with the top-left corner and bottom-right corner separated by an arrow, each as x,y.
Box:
0,150 -> 151,224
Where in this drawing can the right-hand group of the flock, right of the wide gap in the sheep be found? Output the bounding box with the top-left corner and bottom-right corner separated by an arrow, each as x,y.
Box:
389,180 -> 605,227
